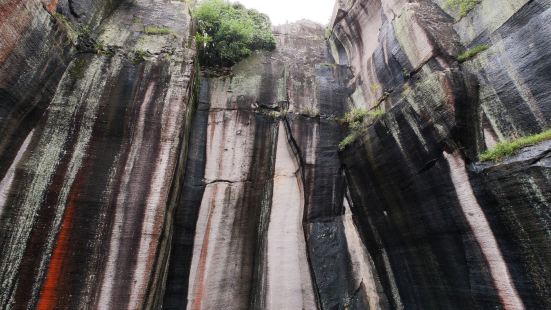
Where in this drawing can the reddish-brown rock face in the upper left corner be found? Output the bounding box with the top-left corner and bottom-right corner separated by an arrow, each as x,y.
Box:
0,0 -> 116,194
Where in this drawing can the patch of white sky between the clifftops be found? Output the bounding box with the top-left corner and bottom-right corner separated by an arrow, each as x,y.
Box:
232,0 -> 335,25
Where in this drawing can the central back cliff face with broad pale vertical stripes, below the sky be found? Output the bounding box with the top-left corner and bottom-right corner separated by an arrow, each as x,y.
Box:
164,21 -> 386,309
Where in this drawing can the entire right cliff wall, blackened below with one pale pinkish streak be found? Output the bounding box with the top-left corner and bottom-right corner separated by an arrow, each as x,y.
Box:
329,0 -> 551,309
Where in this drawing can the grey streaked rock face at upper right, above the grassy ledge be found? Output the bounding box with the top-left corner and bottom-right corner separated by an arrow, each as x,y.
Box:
462,1 -> 551,140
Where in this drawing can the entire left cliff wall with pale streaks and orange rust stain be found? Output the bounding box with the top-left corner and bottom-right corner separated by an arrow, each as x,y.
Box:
0,1 -> 195,309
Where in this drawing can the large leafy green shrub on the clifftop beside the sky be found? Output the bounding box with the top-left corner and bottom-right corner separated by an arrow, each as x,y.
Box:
193,0 -> 276,67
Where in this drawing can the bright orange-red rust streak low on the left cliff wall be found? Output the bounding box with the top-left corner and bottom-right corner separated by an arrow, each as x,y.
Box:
37,177 -> 80,310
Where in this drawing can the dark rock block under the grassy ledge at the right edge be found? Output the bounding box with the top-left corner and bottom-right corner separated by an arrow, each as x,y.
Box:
471,141 -> 551,308
